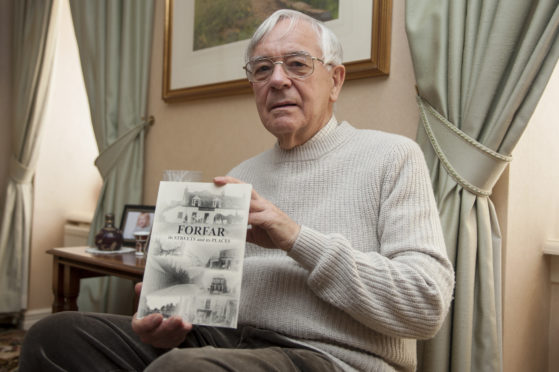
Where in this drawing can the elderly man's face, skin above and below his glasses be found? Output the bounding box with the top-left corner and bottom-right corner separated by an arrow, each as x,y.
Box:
252,20 -> 345,149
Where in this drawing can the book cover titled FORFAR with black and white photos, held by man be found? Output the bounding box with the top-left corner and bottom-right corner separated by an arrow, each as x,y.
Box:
137,181 -> 252,328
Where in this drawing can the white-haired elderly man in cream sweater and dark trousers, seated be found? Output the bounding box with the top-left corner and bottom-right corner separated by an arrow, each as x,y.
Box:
21,10 -> 454,372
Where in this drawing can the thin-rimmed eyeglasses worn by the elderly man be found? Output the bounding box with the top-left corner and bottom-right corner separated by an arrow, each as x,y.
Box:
243,52 -> 324,83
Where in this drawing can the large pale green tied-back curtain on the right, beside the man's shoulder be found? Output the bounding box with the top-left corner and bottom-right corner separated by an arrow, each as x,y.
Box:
406,0 -> 559,372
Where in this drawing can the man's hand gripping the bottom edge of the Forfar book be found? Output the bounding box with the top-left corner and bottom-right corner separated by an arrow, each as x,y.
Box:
132,283 -> 192,349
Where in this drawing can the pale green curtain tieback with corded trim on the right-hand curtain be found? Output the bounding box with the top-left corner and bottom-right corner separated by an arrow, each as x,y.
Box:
417,96 -> 512,196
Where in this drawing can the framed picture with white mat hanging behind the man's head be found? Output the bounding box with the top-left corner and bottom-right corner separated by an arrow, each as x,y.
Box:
163,0 -> 392,102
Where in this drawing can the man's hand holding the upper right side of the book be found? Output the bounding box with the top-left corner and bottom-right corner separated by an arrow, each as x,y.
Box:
214,176 -> 301,252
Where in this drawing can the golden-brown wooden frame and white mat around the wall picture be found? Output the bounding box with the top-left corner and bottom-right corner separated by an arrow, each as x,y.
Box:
162,0 -> 393,102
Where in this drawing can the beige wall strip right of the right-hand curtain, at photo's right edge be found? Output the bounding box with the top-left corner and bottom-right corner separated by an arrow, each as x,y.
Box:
503,61 -> 559,372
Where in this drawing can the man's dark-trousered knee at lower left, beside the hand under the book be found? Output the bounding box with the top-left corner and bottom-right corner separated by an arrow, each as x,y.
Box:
20,311 -> 143,372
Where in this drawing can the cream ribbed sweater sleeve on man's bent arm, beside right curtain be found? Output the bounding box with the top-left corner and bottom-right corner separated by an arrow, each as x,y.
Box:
289,144 -> 454,339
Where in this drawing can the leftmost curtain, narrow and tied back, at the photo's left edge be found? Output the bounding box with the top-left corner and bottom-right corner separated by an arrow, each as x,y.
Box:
0,0 -> 58,313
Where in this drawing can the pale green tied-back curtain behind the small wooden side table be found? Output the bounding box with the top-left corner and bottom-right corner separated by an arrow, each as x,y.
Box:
70,0 -> 154,312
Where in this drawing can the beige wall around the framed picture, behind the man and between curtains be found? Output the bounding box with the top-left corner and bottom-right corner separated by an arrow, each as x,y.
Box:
144,1 -> 418,204
